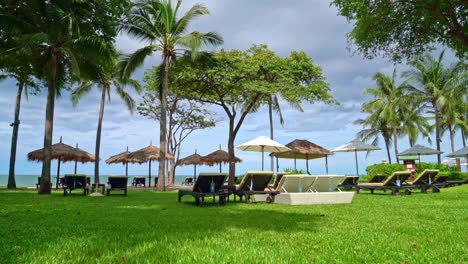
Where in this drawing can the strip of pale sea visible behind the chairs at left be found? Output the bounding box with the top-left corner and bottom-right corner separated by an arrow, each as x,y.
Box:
0,174 -> 193,187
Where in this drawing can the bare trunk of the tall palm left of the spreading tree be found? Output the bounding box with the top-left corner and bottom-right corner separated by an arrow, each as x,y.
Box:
157,54 -> 171,192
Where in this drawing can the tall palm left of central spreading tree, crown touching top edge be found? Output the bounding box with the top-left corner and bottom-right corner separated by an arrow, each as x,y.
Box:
120,0 -> 223,191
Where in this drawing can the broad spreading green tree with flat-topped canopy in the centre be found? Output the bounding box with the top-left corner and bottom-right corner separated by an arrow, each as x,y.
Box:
166,45 -> 335,183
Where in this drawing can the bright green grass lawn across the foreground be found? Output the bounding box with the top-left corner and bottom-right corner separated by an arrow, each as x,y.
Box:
0,185 -> 468,263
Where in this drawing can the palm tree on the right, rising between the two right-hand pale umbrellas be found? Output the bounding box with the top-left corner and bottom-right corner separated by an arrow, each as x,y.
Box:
362,69 -> 409,163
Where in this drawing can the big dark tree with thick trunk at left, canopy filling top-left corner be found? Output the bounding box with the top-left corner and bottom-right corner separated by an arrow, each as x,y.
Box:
0,0 -> 118,194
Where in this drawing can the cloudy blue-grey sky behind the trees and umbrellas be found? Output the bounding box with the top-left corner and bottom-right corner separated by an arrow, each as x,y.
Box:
0,0 -> 461,179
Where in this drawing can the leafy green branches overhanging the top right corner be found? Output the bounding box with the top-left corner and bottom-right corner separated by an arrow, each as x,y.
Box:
332,0 -> 468,61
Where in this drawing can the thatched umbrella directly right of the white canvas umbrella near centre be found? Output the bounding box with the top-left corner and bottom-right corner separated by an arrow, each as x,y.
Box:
270,139 -> 333,174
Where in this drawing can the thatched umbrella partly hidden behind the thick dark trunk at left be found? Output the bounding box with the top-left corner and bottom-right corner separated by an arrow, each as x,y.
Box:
28,137 -> 95,189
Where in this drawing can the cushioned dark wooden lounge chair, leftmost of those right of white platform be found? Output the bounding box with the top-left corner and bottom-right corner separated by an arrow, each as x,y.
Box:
356,171 -> 411,195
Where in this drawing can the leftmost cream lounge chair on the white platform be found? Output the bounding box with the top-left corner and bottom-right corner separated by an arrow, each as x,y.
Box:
276,174 -> 317,193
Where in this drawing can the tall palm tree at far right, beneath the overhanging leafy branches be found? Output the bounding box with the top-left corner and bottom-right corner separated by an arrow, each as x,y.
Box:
403,51 -> 466,164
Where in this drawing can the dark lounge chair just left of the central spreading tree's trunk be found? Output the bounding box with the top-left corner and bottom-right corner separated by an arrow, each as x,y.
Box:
179,173 -> 229,206
